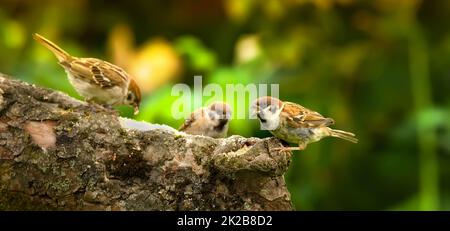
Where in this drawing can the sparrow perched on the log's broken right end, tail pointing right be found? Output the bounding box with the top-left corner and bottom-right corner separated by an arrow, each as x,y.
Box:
252,96 -> 358,151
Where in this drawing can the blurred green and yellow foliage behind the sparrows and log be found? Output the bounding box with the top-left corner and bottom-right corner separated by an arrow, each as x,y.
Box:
0,0 -> 450,210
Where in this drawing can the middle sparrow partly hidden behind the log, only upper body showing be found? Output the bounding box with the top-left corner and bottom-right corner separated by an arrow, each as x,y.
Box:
179,102 -> 231,138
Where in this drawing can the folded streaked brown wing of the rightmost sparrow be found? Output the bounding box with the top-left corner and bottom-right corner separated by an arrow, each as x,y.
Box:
282,102 -> 334,128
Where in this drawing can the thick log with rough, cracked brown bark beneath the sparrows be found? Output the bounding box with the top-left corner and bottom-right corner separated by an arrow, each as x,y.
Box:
0,74 -> 292,210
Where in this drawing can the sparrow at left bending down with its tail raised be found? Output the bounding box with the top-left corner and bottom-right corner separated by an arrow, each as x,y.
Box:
33,34 -> 141,114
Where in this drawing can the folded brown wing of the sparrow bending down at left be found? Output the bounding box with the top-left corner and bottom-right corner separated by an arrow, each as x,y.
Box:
69,58 -> 129,88
